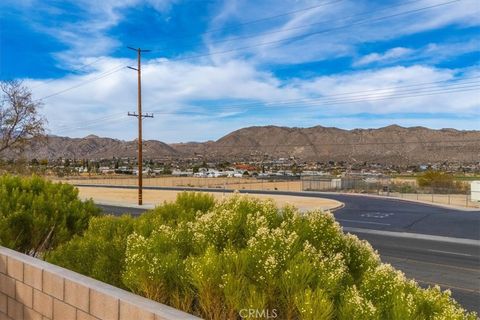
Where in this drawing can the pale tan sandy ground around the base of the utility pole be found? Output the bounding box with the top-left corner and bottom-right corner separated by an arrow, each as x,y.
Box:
78,187 -> 342,211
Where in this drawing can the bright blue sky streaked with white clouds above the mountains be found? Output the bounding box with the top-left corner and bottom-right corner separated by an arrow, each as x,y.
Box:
0,0 -> 480,142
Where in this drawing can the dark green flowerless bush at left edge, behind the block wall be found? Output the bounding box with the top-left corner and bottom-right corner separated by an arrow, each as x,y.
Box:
0,175 -> 100,256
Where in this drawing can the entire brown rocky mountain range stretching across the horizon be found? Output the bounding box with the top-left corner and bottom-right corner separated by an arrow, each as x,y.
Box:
7,125 -> 480,164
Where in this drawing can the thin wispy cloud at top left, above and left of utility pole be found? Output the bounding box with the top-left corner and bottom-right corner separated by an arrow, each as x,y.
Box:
5,0 -> 179,68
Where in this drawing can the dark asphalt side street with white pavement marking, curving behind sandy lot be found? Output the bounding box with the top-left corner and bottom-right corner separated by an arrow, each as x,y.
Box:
87,185 -> 480,240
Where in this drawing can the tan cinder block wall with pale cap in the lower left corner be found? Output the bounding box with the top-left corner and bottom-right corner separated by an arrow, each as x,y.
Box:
0,247 -> 199,320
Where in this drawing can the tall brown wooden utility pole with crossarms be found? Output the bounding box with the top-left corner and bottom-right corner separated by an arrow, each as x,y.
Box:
128,47 -> 153,205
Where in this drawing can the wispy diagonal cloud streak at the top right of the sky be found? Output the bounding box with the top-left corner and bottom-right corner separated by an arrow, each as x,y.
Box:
206,0 -> 480,64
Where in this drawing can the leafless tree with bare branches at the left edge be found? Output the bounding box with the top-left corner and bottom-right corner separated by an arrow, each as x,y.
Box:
0,80 -> 46,154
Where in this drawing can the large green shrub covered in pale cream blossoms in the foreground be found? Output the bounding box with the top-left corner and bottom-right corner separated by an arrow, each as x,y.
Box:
48,193 -> 476,320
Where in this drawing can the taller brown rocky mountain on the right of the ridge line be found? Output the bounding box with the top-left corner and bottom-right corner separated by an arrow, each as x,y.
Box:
172,125 -> 480,163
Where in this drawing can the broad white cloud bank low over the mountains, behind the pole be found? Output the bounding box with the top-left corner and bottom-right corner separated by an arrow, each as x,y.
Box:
28,58 -> 480,142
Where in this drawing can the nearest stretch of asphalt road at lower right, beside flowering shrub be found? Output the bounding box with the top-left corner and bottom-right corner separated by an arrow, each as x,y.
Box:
347,229 -> 480,314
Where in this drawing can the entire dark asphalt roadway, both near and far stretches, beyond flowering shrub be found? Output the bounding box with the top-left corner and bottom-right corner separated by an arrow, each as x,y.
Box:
94,188 -> 480,313
